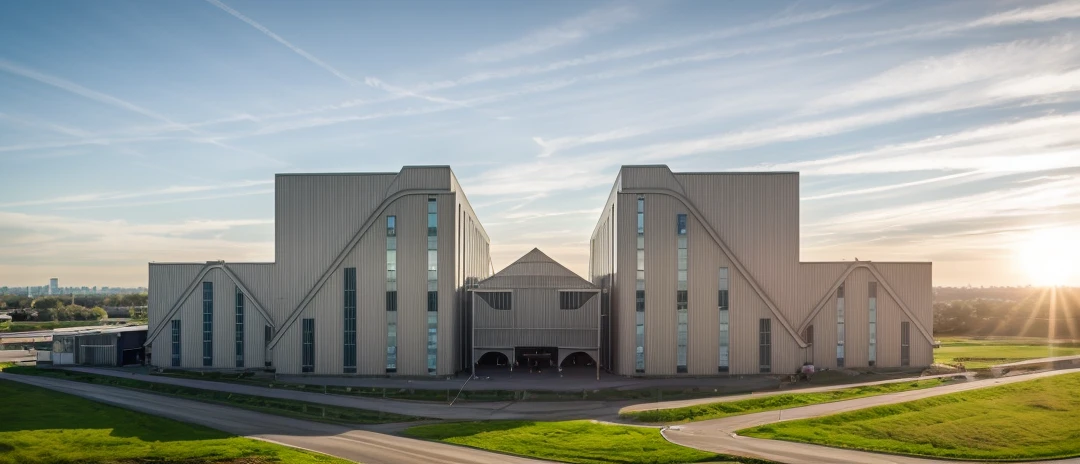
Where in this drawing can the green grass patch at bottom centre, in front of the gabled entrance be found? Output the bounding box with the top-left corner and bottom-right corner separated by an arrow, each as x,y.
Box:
405,421 -> 762,464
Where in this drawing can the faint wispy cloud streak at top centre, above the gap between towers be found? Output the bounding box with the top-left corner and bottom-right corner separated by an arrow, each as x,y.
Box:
465,3 -> 638,63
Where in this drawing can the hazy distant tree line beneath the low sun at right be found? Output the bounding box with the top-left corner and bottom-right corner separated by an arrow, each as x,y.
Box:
934,287 -> 1080,339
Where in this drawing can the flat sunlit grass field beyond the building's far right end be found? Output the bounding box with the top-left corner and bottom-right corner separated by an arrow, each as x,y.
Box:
934,338 -> 1080,369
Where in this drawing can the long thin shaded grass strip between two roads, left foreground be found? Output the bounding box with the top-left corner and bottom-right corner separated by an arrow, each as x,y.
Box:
2,367 -> 422,424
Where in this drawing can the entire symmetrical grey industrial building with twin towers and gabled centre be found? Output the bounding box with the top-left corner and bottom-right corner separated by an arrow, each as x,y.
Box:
147,166 -> 933,377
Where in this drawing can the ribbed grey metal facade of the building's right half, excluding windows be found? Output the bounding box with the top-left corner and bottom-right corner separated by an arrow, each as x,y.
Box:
590,166 -> 933,376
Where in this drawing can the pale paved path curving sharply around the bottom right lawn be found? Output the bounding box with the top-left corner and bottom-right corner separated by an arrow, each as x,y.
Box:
663,369 -> 1080,464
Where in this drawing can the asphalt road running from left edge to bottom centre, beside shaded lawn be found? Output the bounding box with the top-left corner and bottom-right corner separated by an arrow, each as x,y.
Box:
0,372 -> 542,464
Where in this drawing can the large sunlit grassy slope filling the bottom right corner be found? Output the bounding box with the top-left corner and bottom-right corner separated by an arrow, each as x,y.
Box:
739,373 -> 1080,461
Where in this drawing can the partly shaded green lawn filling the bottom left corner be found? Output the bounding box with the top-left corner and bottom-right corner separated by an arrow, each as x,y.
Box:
0,380 -> 348,464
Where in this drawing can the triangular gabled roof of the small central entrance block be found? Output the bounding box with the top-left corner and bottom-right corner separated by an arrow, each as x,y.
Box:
476,248 -> 598,289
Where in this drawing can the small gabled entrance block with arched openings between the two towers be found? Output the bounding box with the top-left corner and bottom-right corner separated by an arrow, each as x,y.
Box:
470,248 -> 600,378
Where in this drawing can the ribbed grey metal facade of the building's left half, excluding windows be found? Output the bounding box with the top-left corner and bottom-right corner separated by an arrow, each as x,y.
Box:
149,167 -> 490,376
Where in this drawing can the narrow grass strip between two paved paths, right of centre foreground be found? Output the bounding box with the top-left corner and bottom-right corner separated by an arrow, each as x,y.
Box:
619,379 -> 949,423
